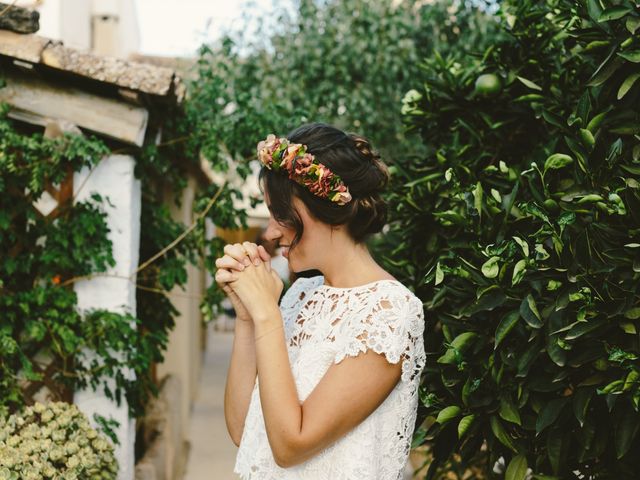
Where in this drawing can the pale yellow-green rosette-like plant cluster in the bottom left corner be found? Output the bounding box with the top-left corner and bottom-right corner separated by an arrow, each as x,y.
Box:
0,402 -> 118,480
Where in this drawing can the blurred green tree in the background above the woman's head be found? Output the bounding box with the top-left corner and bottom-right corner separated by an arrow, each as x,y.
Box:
189,0 -> 499,165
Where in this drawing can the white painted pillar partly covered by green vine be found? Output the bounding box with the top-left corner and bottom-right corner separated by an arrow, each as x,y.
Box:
73,155 -> 141,480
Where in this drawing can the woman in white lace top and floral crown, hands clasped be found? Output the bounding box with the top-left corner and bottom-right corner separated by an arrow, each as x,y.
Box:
216,124 -> 425,480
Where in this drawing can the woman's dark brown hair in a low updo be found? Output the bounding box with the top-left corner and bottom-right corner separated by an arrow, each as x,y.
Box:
260,123 -> 389,246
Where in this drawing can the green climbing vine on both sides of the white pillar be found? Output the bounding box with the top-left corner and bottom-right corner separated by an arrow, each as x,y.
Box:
0,59 -> 252,416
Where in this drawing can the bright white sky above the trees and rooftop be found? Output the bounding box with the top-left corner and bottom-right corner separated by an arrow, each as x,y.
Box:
135,0 -> 281,56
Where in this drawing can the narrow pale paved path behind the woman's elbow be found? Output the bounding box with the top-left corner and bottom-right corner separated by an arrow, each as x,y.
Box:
184,325 -> 239,480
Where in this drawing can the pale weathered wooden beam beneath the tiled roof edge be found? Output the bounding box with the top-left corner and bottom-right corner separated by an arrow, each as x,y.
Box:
0,72 -> 149,146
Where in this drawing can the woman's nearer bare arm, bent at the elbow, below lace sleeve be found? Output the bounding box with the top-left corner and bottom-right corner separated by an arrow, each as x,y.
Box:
254,310 -> 402,468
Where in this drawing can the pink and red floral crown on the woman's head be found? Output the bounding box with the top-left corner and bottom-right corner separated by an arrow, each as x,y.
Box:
258,134 -> 351,205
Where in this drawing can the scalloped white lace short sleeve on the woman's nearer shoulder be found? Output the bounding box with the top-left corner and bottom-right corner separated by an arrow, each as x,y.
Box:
334,291 -> 425,382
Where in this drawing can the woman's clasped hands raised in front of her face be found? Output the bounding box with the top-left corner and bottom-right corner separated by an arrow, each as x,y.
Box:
215,242 -> 284,323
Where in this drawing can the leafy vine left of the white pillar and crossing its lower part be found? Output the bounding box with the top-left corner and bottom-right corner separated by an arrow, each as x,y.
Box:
0,101 -> 174,420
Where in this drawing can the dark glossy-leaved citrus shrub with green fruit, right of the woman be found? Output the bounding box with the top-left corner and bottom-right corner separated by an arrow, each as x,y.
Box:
387,0 -> 640,478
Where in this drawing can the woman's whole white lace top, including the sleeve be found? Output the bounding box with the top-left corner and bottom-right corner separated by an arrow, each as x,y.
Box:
235,277 -> 425,480
